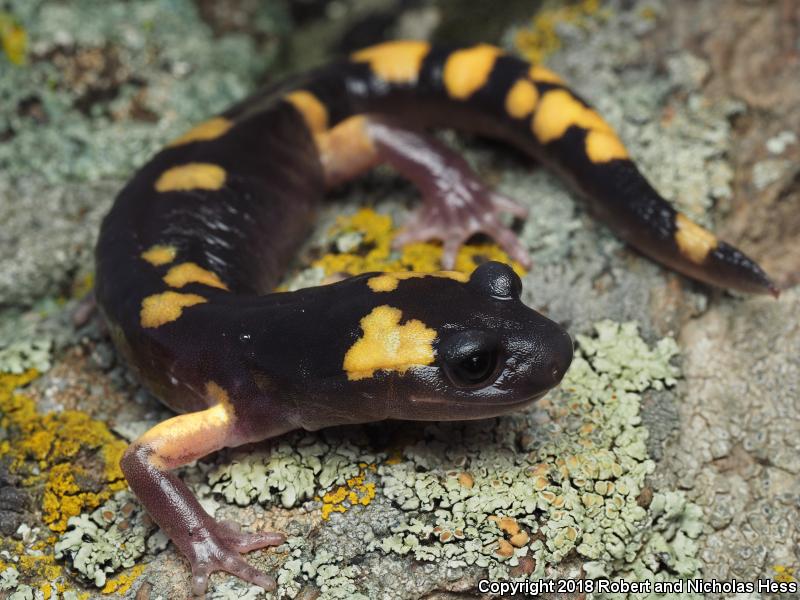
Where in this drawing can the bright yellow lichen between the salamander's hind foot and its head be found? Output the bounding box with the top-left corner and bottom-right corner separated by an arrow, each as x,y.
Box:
314,208 -> 525,276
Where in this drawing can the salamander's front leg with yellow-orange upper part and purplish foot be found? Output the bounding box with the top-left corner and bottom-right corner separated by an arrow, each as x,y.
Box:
121,392 -> 285,594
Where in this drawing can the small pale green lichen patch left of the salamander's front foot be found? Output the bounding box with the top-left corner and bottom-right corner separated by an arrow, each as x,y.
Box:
54,490 -> 167,588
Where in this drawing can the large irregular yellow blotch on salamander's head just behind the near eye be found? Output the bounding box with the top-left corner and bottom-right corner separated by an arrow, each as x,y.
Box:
342,305 -> 436,381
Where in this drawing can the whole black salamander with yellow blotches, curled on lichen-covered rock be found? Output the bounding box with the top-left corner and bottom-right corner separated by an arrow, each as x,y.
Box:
96,41 -> 777,593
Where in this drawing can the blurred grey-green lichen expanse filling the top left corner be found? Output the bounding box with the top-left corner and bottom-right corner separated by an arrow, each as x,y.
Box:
0,0 -> 280,181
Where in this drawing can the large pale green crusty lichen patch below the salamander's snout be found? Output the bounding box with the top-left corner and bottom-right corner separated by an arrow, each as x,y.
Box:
368,321 -> 677,578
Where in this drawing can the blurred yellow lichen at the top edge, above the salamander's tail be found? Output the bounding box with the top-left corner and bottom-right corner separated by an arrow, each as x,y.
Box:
514,0 -> 600,63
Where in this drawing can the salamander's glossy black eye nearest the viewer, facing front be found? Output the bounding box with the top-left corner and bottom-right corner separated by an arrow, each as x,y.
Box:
439,331 -> 500,387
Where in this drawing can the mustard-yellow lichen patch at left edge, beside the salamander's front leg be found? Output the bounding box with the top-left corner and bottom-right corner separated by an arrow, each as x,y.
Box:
0,370 -> 126,532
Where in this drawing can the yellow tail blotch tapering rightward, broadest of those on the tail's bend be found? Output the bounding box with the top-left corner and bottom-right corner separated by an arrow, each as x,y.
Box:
532,90 -> 614,144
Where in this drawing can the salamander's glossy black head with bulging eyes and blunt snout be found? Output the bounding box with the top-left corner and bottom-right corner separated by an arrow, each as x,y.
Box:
354,262 -> 572,420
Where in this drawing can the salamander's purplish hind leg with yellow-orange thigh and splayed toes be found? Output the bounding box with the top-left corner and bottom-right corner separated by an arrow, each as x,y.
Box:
318,116 -> 531,269
